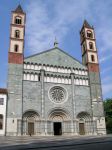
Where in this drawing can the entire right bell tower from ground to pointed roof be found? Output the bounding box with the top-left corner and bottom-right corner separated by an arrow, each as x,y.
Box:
80,20 -> 106,134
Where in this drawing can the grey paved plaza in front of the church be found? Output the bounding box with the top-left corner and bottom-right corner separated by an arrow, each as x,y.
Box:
0,135 -> 112,150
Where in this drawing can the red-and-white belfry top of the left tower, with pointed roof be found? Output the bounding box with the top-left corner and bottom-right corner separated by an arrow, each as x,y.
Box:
8,5 -> 25,64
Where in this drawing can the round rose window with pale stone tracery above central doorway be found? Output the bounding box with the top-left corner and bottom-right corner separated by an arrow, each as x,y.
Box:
49,86 -> 67,103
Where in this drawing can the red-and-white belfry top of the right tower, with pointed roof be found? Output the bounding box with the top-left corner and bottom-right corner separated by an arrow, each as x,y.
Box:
80,20 -> 99,72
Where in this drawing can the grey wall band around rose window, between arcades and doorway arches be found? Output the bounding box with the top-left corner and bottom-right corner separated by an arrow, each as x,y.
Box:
23,81 -> 91,119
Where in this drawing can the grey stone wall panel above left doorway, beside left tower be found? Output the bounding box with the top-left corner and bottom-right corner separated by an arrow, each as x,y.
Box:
23,81 -> 41,115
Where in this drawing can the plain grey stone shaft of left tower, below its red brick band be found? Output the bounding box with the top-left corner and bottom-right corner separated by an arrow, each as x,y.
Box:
7,64 -> 23,117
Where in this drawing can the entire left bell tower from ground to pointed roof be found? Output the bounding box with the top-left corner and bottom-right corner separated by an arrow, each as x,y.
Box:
6,5 -> 26,135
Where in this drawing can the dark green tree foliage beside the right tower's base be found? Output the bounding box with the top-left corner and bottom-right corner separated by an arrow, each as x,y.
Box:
104,98 -> 112,133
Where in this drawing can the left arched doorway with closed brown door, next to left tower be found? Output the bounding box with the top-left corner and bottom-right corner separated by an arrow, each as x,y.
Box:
23,111 -> 39,135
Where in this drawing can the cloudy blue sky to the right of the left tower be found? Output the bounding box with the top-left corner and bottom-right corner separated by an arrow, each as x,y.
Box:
26,0 -> 112,99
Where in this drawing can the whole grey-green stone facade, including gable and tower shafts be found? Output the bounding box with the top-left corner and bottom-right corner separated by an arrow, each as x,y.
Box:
7,49 -> 103,134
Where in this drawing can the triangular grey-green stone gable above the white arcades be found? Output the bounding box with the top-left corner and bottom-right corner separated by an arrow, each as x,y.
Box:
24,48 -> 86,69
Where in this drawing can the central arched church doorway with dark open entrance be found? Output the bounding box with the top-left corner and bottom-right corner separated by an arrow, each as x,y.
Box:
49,109 -> 70,135
